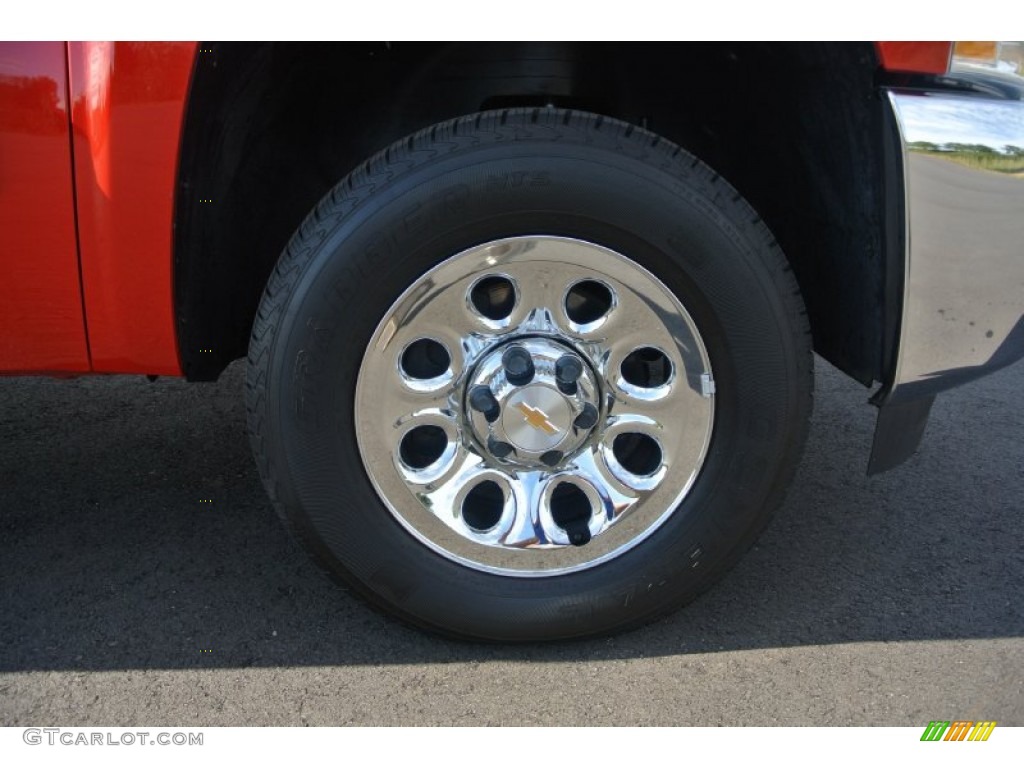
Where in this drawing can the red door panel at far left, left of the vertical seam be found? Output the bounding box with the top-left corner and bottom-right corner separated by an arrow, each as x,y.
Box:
0,43 -> 89,374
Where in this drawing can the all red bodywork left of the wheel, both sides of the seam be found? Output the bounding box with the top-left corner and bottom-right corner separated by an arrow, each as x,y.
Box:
0,42 -> 197,375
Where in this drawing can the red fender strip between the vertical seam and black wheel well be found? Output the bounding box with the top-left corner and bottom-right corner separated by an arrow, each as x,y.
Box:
69,43 -> 196,376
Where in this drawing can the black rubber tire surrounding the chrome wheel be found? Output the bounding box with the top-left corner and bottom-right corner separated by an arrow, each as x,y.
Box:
247,109 -> 813,641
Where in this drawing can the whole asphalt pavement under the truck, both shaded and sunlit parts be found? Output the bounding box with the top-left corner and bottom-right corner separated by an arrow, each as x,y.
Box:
0,359 -> 1024,727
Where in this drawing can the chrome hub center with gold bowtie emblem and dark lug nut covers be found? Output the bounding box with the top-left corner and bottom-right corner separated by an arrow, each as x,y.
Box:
463,337 -> 601,469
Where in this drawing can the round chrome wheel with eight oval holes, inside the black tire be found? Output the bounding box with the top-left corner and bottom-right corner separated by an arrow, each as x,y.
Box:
354,236 -> 715,577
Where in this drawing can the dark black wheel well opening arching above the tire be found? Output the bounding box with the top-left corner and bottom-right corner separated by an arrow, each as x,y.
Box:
174,43 -> 893,384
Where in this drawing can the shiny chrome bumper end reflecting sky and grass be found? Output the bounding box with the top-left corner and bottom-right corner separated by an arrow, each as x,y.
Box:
881,91 -> 1024,403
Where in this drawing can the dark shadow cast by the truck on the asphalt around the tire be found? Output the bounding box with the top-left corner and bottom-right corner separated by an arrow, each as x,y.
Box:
0,360 -> 1024,671
